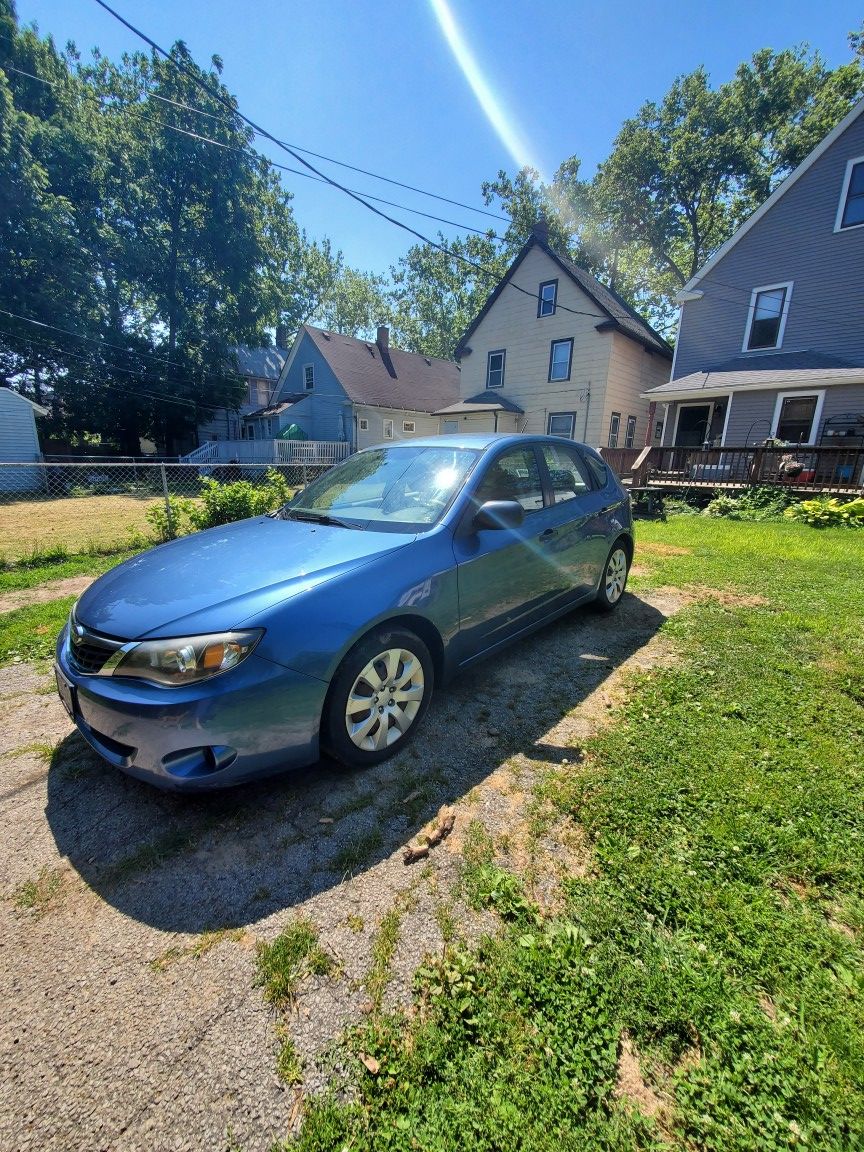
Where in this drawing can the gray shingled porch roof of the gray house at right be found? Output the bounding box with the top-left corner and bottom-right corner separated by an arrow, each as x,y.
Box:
642,348 -> 864,400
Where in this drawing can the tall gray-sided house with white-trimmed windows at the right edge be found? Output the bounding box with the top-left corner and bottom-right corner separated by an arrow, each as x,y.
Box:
643,95 -> 864,453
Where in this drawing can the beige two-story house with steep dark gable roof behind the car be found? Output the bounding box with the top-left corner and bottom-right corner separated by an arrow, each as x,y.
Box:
453,223 -> 672,448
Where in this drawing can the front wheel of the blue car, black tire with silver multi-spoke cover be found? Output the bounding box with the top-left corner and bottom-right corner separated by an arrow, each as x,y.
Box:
321,628 -> 434,768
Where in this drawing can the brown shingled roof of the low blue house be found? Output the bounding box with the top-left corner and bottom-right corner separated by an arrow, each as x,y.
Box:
281,324 -> 460,412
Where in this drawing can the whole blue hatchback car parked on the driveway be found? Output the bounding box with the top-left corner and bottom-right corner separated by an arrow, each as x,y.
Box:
55,435 -> 634,790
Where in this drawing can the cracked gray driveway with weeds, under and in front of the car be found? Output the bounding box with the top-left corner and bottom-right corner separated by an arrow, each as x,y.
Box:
0,592 -> 681,1152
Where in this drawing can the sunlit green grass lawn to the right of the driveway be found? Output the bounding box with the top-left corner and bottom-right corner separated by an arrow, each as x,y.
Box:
297,517 -> 864,1152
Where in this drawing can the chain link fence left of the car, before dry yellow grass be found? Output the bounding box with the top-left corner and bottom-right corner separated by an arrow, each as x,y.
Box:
0,461 -> 332,563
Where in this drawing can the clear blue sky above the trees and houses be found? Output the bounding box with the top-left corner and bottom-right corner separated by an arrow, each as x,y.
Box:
17,0 -> 861,273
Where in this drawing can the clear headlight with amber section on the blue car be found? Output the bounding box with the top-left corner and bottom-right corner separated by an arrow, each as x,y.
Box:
111,629 -> 264,688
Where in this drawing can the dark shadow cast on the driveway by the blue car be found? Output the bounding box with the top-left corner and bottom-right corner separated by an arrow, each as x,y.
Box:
46,593 -> 666,933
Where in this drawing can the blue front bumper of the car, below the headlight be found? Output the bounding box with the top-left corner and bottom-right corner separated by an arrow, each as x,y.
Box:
56,628 -> 327,791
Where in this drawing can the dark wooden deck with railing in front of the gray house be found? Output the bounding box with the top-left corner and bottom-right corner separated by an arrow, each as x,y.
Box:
600,445 -> 864,498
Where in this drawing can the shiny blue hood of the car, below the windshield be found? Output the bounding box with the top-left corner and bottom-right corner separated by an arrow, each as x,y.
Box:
75,516 -> 414,639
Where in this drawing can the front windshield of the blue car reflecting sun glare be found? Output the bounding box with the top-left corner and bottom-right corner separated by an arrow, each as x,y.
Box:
288,445 -> 479,532
